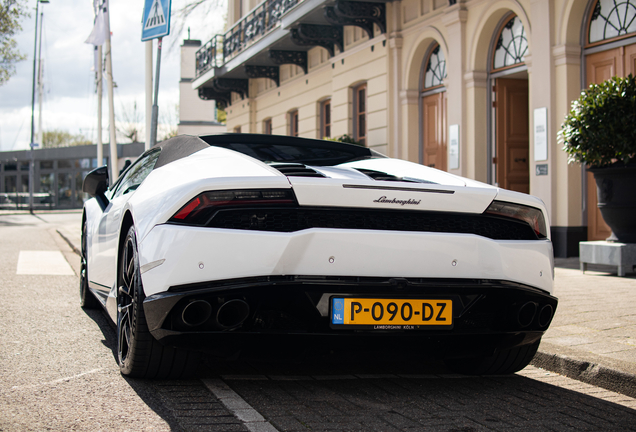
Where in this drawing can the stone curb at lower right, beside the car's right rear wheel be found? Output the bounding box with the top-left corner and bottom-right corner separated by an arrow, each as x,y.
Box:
530,351 -> 636,398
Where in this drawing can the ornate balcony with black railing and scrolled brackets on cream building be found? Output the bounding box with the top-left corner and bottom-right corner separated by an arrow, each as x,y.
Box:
192,0 -> 390,105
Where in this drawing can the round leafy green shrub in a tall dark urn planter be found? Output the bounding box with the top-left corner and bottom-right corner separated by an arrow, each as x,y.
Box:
559,74 -> 636,243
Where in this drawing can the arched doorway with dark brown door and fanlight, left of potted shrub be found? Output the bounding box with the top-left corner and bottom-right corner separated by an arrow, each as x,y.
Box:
489,13 -> 530,193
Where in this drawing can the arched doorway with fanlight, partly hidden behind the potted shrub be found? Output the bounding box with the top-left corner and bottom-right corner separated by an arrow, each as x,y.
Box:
581,0 -> 636,240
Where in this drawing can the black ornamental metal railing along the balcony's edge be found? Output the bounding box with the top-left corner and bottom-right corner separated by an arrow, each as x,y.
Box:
196,0 -> 303,77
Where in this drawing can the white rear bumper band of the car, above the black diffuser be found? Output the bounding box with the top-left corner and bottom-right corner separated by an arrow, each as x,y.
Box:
139,224 -> 553,296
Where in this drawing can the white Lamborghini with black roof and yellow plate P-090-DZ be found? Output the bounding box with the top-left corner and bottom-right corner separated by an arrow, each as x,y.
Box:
80,134 -> 557,378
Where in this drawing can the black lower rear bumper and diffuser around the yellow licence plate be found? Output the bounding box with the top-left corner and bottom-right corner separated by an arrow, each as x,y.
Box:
144,276 -> 557,357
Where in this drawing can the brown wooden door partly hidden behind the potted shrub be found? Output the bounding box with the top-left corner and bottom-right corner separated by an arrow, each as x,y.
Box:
585,49 -> 634,241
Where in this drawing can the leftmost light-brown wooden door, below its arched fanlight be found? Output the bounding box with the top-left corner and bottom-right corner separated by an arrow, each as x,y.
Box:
422,92 -> 447,171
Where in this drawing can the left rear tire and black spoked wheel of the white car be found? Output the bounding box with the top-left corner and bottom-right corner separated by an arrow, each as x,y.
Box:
117,227 -> 199,379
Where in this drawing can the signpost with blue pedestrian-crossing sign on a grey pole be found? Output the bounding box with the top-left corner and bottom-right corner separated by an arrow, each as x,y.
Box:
141,0 -> 172,147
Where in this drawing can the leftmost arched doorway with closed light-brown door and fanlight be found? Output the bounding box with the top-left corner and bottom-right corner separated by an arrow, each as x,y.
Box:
420,43 -> 448,171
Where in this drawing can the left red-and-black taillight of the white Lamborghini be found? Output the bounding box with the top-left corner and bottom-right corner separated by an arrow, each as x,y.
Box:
170,189 -> 296,225
